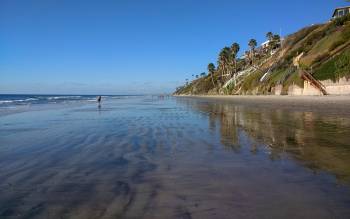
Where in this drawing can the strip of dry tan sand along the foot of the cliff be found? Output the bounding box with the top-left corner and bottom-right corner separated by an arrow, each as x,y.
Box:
175,95 -> 350,115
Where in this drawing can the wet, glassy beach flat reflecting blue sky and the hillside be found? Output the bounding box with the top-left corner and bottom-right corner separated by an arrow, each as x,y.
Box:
0,97 -> 350,219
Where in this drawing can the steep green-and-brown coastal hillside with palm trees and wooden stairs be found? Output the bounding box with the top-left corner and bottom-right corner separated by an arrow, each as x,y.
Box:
174,15 -> 350,95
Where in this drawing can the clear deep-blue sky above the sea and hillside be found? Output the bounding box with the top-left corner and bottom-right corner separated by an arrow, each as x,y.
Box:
0,0 -> 350,94
